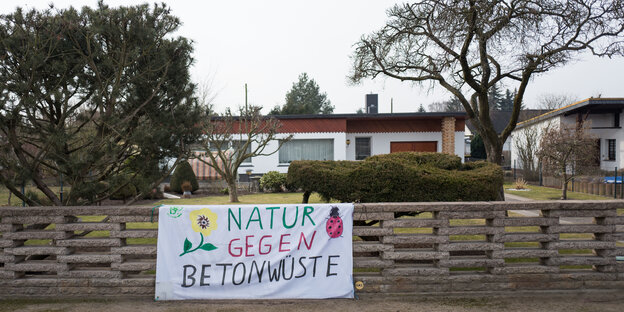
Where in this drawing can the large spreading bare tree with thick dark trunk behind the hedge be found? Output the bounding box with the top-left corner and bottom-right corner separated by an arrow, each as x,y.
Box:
350,0 -> 624,171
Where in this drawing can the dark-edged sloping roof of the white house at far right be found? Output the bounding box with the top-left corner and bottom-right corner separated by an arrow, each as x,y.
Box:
516,98 -> 624,129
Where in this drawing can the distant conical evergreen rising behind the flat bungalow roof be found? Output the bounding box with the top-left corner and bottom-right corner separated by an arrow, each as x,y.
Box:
269,73 -> 334,115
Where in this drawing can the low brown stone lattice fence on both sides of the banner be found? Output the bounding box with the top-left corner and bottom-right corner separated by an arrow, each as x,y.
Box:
0,201 -> 624,297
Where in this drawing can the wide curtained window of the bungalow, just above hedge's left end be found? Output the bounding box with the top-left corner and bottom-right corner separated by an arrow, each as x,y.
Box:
279,139 -> 334,164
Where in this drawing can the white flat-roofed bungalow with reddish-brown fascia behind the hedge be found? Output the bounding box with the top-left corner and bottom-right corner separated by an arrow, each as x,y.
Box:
191,112 -> 466,181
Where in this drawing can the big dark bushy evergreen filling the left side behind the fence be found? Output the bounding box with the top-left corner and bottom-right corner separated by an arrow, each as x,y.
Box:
0,2 -> 202,205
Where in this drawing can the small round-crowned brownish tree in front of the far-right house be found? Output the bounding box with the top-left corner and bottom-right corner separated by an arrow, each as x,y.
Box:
537,123 -> 598,199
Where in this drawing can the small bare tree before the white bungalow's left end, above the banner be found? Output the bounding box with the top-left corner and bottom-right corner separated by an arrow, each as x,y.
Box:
199,106 -> 292,202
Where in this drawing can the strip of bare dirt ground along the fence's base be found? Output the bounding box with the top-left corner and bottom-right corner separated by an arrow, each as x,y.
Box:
0,291 -> 624,312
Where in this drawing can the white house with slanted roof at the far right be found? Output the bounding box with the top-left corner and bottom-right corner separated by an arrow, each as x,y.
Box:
511,98 -> 624,170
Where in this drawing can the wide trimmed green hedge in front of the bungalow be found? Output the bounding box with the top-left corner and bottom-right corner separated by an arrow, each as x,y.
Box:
287,152 -> 503,203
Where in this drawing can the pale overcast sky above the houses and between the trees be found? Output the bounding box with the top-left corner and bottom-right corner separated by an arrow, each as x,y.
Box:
0,0 -> 624,113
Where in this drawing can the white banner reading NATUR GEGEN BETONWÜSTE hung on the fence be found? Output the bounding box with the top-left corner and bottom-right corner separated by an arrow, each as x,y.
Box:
155,204 -> 353,300
